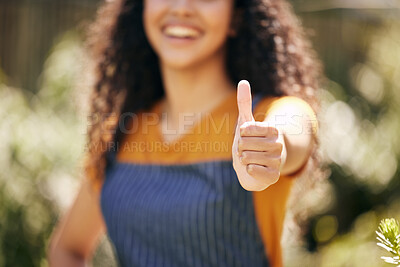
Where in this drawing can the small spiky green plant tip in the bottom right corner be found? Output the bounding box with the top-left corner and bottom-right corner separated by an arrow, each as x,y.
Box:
376,218 -> 400,266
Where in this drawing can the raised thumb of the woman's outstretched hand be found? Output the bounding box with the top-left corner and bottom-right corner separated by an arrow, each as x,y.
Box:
237,80 -> 254,125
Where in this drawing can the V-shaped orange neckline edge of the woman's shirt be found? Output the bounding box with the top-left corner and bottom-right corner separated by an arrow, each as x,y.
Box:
154,90 -> 236,147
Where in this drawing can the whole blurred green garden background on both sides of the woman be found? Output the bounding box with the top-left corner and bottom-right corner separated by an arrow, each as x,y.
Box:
0,0 -> 400,266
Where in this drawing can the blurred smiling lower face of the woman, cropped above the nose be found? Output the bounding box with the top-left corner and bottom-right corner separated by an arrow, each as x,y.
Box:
143,0 -> 234,68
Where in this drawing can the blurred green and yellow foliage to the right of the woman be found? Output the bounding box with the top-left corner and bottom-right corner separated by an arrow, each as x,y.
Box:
285,10 -> 400,267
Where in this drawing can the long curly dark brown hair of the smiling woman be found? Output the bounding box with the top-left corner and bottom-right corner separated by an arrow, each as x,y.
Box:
84,0 -> 322,194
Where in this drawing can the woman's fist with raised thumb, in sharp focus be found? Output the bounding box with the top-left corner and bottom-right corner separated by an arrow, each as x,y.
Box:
232,80 -> 285,191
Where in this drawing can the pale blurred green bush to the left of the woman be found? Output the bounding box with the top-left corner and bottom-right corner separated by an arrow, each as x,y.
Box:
0,33 -> 84,267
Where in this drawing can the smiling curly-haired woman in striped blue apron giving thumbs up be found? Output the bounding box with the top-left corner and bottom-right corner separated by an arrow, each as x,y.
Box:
49,0 -> 320,266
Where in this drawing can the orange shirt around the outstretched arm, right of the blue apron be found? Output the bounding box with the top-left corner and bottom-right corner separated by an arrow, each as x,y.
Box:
253,96 -> 318,267
